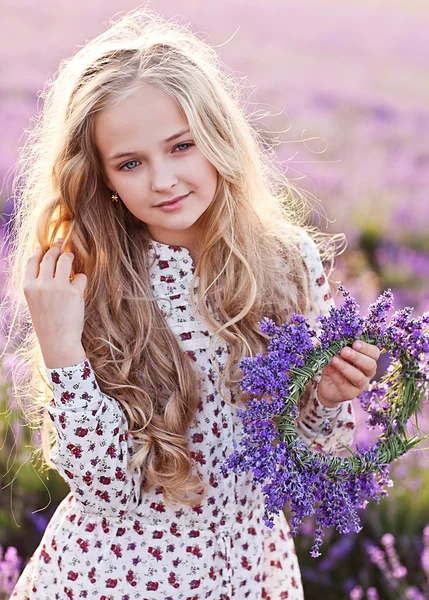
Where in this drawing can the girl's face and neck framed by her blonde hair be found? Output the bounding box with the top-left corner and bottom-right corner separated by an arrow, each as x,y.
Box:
95,84 -> 218,262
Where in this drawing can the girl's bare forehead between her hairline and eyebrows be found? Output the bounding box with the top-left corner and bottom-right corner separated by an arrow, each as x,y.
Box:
94,84 -> 188,154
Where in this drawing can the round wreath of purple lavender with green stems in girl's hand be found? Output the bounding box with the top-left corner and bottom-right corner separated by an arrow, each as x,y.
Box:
221,283 -> 429,557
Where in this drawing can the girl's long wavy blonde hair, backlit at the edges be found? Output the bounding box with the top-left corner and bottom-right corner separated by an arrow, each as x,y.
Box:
3,8 -> 340,504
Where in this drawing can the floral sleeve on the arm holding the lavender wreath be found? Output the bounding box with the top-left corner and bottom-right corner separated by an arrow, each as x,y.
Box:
296,231 -> 355,452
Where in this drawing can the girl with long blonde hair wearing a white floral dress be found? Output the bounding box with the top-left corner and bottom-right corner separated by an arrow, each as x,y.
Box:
6,8 -> 379,600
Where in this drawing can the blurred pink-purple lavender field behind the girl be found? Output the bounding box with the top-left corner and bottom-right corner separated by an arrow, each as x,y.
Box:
0,0 -> 429,600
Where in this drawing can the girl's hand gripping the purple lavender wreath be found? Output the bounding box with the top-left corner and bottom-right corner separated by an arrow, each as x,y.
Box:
317,340 -> 380,408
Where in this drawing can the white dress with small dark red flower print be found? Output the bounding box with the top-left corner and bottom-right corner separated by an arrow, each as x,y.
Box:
11,234 -> 354,600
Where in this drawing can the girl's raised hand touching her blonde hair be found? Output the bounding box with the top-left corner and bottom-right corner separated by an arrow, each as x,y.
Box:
23,240 -> 87,368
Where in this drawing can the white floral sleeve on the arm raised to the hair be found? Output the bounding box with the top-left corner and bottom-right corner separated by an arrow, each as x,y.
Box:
46,359 -> 140,517
